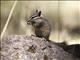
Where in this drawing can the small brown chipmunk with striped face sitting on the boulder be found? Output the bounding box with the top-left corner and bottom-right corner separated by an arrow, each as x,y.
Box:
27,10 -> 51,40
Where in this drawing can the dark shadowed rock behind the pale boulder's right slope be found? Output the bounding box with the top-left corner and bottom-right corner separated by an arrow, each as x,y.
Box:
55,41 -> 80,59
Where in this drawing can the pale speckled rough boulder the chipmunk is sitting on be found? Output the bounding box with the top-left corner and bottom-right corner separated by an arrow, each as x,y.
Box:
0,35 -> 79,60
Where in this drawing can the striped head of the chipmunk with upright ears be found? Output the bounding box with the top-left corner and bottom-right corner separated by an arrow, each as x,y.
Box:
27,10 -> 41,24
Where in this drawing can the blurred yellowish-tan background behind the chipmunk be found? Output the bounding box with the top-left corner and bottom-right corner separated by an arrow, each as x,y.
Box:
0,1 -> 80,44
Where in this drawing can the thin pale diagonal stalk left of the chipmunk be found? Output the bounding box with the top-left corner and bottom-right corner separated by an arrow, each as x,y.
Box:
1,1 -> 17,39
